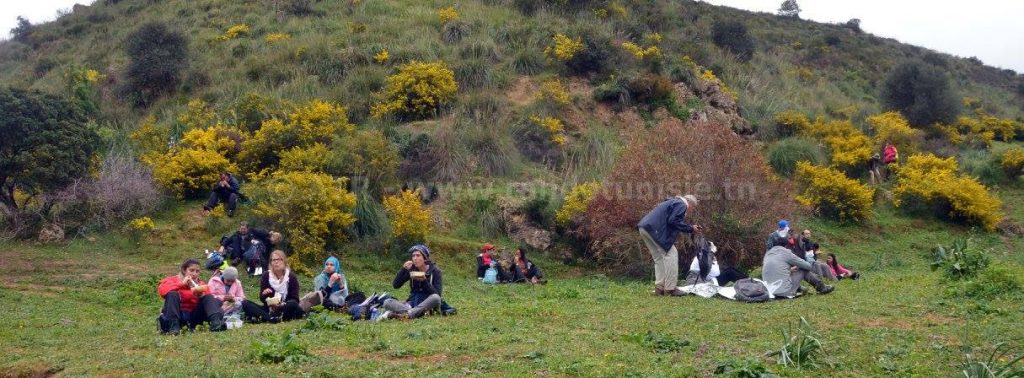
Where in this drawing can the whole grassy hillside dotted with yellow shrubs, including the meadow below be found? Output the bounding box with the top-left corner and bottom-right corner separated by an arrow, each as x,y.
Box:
0,0 -> 1024,376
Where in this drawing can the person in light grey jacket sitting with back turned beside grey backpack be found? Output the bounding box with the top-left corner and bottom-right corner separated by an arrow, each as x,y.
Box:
761,239 -> 835,297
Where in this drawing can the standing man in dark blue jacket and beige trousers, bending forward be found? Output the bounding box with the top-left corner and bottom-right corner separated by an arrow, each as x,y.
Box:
637,195 -> 703,296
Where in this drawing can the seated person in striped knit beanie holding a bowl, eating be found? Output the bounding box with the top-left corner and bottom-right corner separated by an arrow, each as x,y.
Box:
378,244 -> 442,320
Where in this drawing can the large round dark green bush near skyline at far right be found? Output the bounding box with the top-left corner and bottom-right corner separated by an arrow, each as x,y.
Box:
882,61 -> 961,127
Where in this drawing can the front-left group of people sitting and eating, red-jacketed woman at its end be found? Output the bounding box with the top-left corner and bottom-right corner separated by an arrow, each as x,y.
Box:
157,225 -> 456,335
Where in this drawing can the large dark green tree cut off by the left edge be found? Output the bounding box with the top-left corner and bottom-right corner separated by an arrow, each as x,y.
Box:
0,88 -> 99,218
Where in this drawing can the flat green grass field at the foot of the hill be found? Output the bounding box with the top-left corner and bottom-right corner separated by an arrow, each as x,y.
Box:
0,204 -> 1024,376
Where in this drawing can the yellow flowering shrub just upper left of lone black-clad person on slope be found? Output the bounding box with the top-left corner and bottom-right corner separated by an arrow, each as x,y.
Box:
153,149 -> 238,198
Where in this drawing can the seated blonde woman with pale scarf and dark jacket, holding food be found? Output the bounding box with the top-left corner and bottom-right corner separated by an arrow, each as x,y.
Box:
242,249 -> 306,323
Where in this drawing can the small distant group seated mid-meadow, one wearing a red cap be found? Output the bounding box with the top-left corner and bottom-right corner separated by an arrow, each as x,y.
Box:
476,243 -> 547,284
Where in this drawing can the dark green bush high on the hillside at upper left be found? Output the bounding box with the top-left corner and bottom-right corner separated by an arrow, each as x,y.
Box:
123,22 -> 188,107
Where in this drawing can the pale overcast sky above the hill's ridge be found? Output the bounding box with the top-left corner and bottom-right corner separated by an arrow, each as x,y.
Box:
0,0 -> 1024,73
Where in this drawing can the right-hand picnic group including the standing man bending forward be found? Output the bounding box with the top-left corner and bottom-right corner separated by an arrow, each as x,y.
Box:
637,195 -> 860,297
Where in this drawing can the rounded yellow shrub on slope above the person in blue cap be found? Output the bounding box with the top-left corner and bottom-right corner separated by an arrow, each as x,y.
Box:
796,162 -> 874,222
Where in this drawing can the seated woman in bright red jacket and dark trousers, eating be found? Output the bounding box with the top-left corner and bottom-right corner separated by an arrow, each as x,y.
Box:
157,258 -> 226,335
